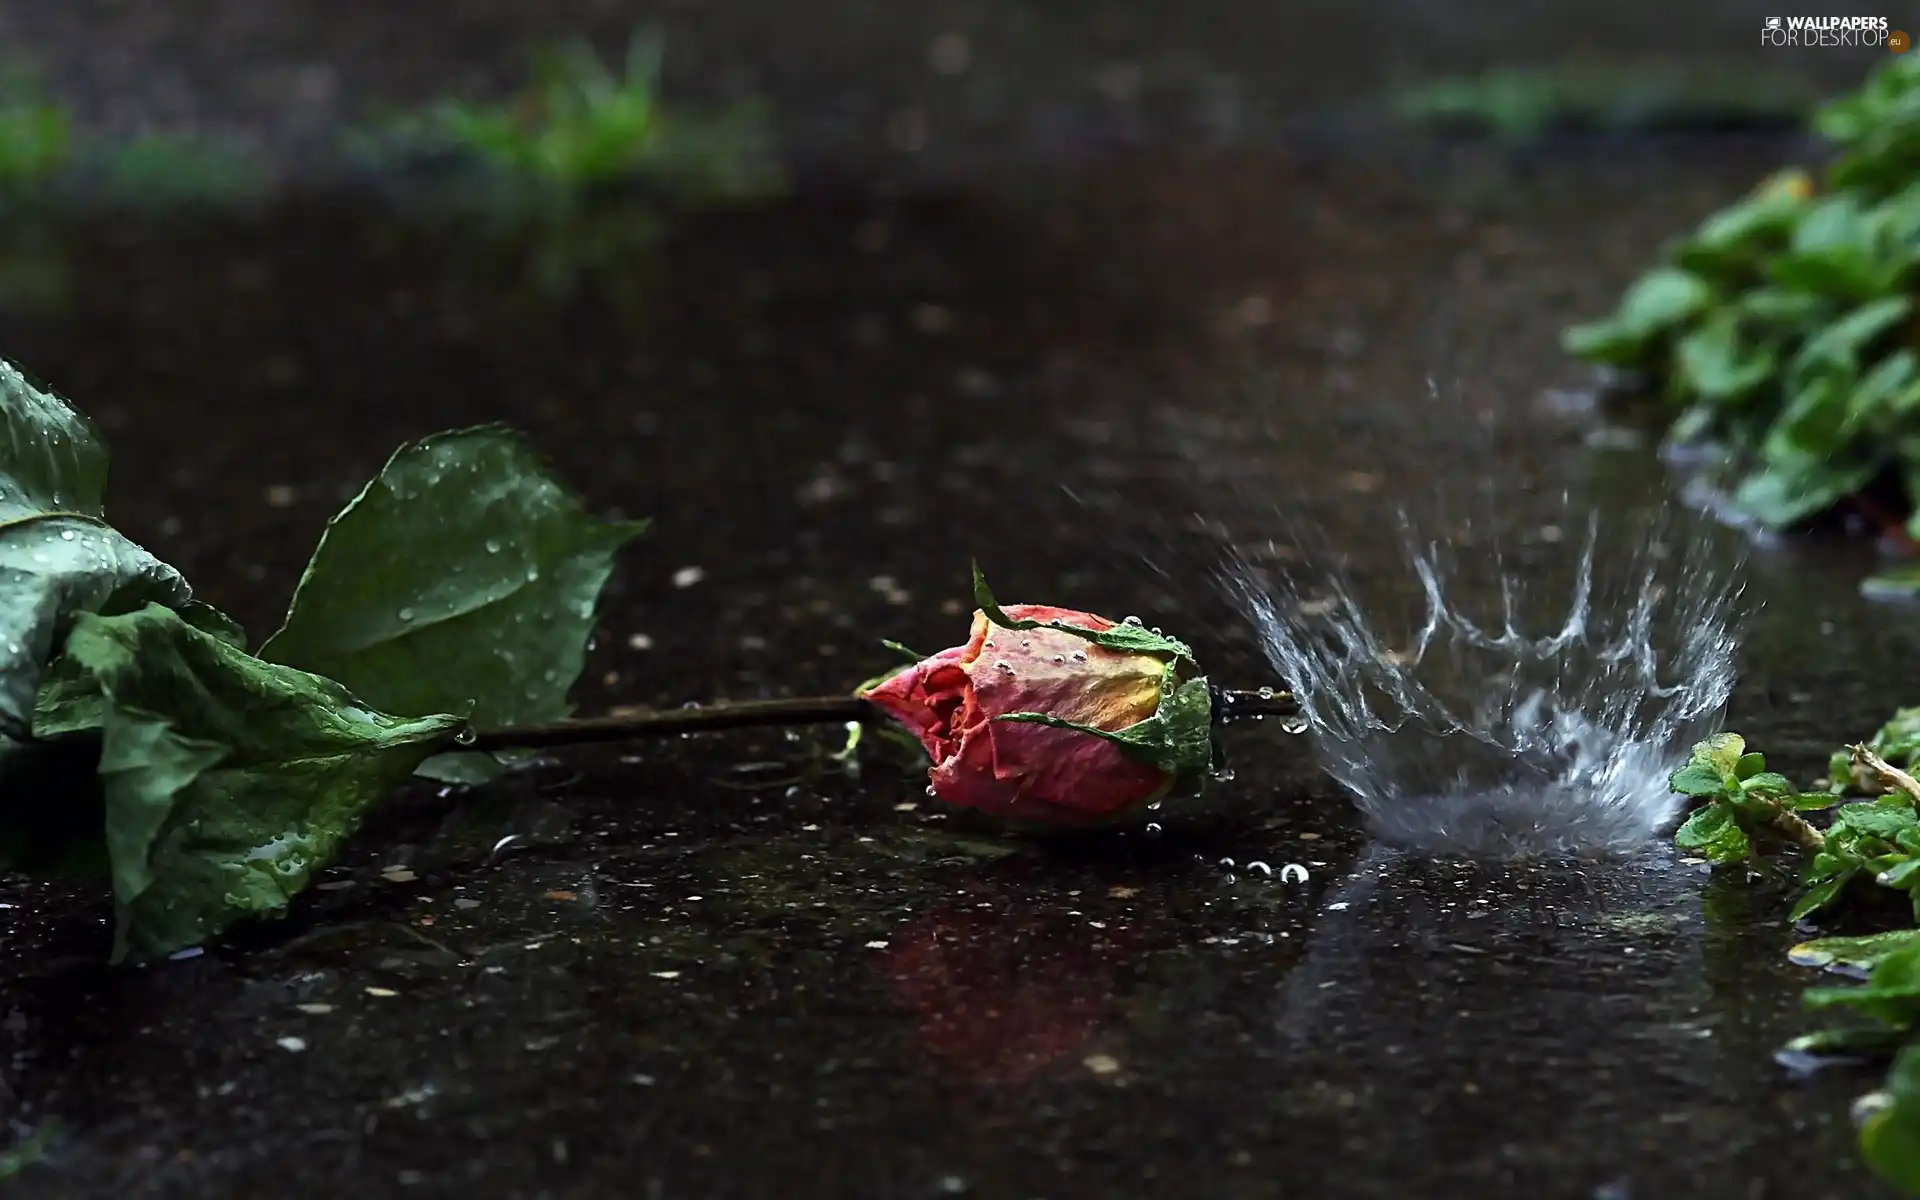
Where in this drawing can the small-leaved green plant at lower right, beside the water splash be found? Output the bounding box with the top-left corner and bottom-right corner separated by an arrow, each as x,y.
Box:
1672,708 -> 1920,1194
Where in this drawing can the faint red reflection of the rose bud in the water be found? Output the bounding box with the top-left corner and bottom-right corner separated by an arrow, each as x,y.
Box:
887,908 -> 1135,1083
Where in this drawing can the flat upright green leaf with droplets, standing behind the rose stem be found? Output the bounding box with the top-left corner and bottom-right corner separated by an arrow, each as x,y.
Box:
259,426 -> 645,783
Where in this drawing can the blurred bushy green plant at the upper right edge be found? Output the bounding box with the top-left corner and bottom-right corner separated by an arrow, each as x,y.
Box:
1565,56 -> 1920,593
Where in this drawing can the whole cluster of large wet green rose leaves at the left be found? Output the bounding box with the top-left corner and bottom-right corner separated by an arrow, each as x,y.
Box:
0,351 -> 643,962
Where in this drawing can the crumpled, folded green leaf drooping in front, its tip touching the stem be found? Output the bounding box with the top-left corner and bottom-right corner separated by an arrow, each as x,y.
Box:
65,605 -> 463,962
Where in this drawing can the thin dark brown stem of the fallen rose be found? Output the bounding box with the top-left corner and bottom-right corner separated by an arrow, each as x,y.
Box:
461,689 -> 1300,751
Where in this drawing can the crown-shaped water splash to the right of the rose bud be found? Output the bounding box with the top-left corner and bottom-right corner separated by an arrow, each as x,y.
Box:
1227,515 -> 1738,856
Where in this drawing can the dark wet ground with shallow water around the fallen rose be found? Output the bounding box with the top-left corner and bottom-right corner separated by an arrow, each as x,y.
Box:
0,4 -> 1920,1200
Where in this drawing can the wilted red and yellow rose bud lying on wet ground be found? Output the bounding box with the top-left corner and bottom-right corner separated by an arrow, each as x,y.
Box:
860,568 -> 1213,828
